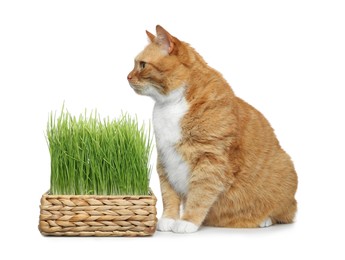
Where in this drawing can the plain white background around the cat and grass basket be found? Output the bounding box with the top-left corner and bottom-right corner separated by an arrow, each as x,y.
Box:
0,0 -> 345,259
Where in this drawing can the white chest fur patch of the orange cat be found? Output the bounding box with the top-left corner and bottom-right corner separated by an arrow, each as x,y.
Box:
153,88 -> 189,195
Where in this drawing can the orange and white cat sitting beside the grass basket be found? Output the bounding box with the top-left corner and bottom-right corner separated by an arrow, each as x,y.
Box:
127,25 -> 297,233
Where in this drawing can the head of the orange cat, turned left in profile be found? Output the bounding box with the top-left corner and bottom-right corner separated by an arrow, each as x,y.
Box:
127,25 -> 194,101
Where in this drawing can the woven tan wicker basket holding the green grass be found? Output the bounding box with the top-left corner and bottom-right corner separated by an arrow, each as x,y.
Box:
39,191 -> 157,236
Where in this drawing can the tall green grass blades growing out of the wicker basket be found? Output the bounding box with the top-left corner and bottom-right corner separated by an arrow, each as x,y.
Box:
46,105 -> 152,195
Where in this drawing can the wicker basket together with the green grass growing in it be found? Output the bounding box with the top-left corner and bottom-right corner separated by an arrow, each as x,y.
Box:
39,106 -> 157,236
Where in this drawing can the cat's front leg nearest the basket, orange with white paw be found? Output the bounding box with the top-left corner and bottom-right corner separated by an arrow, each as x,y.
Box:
157,159 -> 181,231
